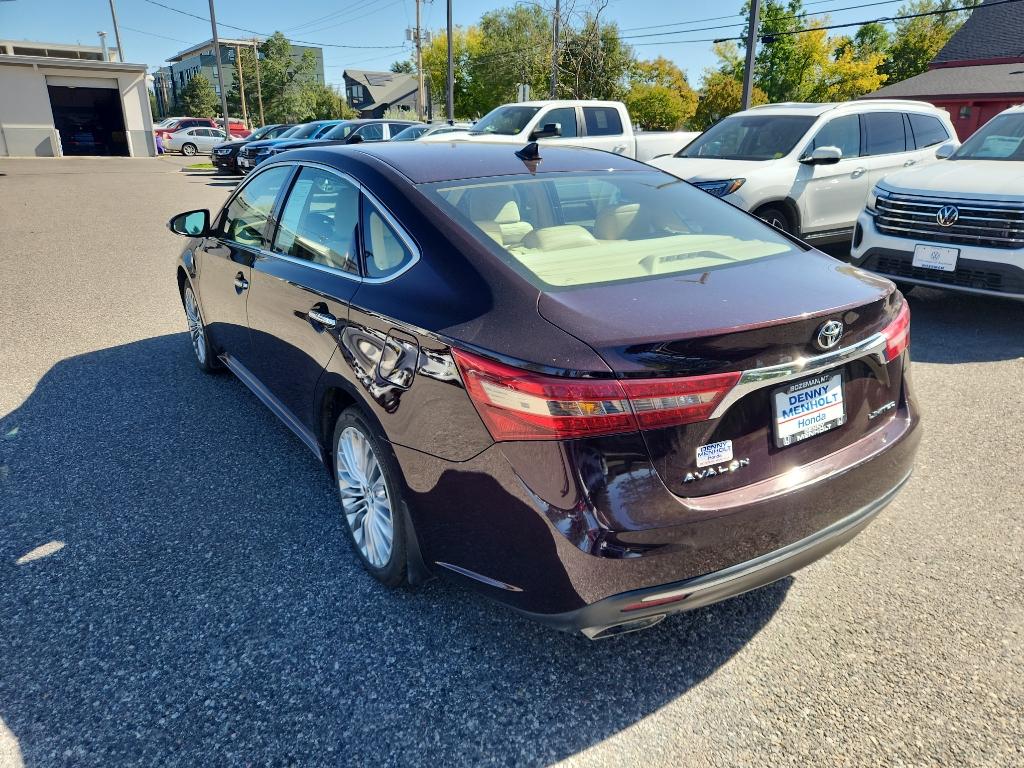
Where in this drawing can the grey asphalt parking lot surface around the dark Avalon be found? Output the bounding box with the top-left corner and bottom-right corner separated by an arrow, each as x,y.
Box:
0,157 -> 1024,768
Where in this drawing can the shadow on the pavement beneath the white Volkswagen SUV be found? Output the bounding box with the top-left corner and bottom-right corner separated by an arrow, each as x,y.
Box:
907,287 -> 1024,362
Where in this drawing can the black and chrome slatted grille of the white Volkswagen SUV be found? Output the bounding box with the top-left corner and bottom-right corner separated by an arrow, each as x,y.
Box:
874,195 -> 1024,248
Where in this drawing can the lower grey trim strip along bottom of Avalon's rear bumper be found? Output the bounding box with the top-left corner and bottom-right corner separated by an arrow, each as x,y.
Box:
522,473 -> 910,640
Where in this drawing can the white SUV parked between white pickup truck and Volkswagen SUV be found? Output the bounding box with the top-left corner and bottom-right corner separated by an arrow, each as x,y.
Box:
650,99 -> 956,244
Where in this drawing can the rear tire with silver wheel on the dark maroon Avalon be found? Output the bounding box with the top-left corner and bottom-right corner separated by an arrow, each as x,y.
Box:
331,407 -> 409,587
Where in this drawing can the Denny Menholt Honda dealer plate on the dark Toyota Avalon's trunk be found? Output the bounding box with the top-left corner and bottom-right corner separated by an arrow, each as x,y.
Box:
772,371 -> 846,447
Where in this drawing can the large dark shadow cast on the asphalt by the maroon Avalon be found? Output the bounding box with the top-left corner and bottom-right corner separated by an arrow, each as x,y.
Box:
0,333 -> 793,766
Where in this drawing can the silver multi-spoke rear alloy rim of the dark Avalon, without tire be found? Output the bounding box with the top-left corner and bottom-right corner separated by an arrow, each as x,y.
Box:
335,427 -> 394,568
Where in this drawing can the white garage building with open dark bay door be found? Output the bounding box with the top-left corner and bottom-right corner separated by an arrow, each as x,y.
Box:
0,44 -> 157,158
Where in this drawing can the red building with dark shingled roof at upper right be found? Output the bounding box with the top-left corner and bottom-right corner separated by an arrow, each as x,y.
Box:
862,0 -> 1024,141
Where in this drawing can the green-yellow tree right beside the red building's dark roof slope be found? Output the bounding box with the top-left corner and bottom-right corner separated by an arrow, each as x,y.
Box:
880,0 -> 978,83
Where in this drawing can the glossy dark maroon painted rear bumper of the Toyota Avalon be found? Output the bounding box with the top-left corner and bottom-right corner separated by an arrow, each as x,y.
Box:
395,376 -> 921,629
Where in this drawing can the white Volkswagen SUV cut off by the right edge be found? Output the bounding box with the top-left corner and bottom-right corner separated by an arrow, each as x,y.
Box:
852,106 -> 1024,299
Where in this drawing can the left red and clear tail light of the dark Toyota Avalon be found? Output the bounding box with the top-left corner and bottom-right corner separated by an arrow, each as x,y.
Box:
452,349 -> 739,440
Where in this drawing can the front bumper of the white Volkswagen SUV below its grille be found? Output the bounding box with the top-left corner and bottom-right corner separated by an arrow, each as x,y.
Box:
851,211 -> 1024,300
